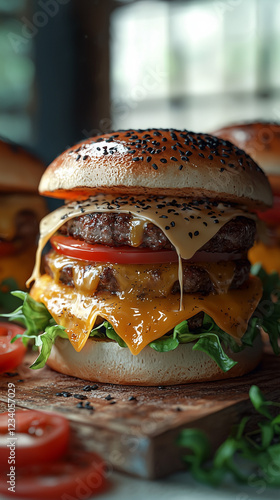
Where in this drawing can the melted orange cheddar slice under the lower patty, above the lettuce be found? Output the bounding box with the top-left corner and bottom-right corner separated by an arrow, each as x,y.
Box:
31,275 -> 262,354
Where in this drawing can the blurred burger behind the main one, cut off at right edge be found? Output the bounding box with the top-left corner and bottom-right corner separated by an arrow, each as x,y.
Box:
214,122 -> 280,273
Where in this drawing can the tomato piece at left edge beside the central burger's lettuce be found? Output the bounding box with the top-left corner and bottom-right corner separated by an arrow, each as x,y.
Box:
0,322 -> 26,373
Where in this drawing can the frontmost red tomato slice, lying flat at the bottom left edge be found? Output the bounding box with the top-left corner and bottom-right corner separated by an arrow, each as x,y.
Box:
0,451 -> 107,500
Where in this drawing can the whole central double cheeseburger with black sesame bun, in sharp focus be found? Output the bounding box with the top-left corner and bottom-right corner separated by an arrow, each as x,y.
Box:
21,129 -> 272,385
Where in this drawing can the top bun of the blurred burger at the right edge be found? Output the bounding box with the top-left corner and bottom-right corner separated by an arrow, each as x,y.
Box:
214,122 -> 280,175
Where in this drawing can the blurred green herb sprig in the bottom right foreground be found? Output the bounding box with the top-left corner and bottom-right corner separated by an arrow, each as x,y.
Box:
178,385 -> 280,487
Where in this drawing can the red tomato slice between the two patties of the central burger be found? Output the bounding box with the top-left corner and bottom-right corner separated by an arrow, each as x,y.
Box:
51,235 -> 178,264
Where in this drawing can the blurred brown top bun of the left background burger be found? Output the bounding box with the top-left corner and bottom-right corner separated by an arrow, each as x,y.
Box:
0,139 -> 44,193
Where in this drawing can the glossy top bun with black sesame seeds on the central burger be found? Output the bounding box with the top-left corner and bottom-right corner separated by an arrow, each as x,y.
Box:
39,129 -> 272,208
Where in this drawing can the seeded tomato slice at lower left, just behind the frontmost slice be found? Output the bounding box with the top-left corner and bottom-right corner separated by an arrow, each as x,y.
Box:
0,410 -> 70,467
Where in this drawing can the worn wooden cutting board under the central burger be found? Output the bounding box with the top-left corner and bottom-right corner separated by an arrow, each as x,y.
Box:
0,353 -> 280,479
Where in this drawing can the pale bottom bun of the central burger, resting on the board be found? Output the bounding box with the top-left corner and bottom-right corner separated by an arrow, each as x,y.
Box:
47,335 -> 262,386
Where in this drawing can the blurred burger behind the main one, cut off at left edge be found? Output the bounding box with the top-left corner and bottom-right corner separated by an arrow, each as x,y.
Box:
0,139 -> 47,312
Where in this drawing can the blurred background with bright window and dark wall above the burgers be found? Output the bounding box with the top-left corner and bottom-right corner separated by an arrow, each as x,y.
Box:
0,0 -> 280,164
